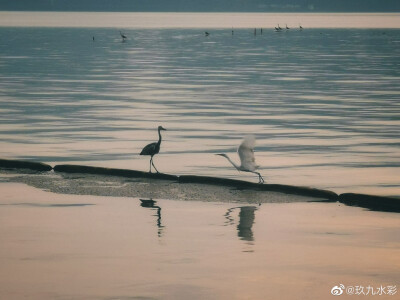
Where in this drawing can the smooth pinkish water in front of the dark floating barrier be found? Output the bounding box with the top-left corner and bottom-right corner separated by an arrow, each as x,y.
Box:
0,182 -> 400,300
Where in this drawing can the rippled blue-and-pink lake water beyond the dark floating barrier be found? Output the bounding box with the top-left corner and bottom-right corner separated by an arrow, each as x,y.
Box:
0,12 -> 400,195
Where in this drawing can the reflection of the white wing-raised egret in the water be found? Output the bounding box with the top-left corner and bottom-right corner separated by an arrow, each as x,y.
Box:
225,206 -> 257,242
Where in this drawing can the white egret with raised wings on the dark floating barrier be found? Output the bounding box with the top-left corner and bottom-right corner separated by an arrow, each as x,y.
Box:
216,136 -> 264,183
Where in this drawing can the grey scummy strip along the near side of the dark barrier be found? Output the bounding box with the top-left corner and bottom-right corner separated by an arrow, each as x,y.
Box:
0,171 -> 318,203
